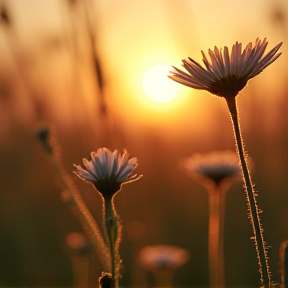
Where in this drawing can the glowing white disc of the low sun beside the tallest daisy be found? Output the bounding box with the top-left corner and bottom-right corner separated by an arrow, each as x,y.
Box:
142,64 -> 180,103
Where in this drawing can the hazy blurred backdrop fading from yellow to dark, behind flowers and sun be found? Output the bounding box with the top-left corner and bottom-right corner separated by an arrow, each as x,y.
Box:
0,0 -> 288,287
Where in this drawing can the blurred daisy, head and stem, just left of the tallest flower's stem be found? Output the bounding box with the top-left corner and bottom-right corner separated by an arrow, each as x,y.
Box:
180,151 -> 241,288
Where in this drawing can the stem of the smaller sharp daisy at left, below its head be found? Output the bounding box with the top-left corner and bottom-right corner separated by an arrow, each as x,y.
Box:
104,197 -> 119,288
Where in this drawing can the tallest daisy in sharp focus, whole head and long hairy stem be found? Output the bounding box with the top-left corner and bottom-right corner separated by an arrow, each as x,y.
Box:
169,38 -> 282,287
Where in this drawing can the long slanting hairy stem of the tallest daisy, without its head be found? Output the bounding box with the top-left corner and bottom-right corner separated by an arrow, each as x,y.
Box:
225,97 -> 271,288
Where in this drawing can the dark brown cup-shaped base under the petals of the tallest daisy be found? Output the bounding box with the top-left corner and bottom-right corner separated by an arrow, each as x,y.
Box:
208,74 -> 248,98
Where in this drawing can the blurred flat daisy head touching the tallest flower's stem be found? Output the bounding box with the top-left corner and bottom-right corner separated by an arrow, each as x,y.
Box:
181,151 -> 241,187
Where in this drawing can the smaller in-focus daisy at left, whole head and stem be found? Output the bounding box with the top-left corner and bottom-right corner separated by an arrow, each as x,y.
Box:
74,147 -> 141,288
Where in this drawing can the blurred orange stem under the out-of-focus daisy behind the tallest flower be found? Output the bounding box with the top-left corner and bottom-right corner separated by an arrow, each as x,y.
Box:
208,186 -> 225,288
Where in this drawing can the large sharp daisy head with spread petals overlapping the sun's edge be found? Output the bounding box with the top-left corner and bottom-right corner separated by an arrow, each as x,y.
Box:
168,38 -> 282,98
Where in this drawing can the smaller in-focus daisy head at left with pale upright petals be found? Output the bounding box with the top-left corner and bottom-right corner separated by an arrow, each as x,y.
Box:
74,147 -> 142,198
